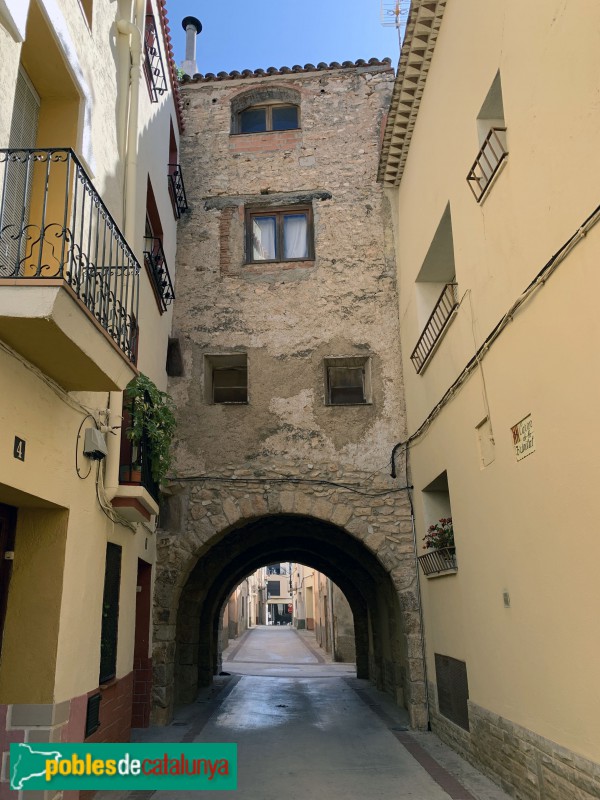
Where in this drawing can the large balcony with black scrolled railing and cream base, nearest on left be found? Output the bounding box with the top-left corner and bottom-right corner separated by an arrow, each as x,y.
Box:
0,148 -> 140,391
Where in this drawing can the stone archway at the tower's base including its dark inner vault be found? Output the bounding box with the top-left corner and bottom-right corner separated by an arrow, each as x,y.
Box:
153,486 -> 427,728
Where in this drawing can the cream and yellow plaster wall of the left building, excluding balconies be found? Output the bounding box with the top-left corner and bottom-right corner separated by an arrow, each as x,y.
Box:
0,0 -> 178,702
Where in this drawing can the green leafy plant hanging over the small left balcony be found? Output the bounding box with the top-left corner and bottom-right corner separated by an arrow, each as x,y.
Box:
125,374 -> 177,485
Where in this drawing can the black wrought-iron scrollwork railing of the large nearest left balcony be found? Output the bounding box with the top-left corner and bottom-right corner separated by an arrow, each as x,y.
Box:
0,148 -> 140,363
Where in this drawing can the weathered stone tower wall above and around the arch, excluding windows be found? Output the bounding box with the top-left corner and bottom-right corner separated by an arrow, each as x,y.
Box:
154,64 -> 425,727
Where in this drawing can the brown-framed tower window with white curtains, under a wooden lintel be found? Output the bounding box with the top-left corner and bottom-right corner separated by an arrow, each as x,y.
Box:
246,208 -> 314,263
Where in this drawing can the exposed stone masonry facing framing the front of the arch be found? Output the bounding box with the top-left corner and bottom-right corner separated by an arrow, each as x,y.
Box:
153,478 -> 427,727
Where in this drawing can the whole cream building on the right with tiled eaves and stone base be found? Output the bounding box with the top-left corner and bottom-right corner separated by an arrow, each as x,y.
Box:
380,0 -> 600,800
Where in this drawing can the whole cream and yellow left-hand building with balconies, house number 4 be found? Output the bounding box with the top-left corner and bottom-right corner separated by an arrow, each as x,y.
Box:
0,0 -> 185,768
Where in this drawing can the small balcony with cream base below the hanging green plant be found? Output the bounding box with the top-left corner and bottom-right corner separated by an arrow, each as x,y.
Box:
112,406 -> 159,522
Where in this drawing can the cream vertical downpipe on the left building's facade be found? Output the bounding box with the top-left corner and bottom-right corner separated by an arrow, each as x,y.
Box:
105,0 -> 144,500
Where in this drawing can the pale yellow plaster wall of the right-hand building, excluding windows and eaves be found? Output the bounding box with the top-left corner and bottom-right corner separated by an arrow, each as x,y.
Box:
391,0 -> 600,760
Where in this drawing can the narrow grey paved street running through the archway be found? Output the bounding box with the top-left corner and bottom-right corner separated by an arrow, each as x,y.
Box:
104,626 -> 508,800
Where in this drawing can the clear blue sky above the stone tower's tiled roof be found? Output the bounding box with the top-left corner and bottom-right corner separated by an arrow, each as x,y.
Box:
167,0 -> 398,74
